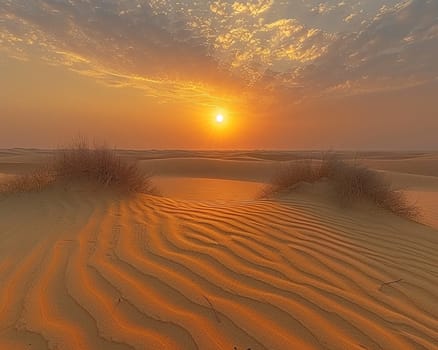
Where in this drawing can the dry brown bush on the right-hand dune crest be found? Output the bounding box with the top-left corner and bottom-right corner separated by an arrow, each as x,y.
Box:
262,154 -> 420,220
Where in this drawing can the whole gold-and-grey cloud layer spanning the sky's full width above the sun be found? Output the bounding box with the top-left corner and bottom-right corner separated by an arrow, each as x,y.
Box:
0,0 -> 438,105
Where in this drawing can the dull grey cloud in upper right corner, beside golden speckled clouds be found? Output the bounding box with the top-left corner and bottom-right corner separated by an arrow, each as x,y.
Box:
294,0 -> 438,98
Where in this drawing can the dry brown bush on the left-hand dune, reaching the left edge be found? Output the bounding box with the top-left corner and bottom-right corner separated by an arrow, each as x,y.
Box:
3,140 -> 158,194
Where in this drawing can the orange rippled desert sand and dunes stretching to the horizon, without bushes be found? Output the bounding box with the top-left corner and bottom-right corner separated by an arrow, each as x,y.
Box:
0,149 -> 438,350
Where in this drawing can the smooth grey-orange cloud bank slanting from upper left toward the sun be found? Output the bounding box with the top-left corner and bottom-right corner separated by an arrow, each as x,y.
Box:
0,0 -> 240,103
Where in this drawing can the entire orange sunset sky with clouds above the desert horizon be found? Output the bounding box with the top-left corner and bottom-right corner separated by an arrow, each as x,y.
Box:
0,0 -> 438,150
